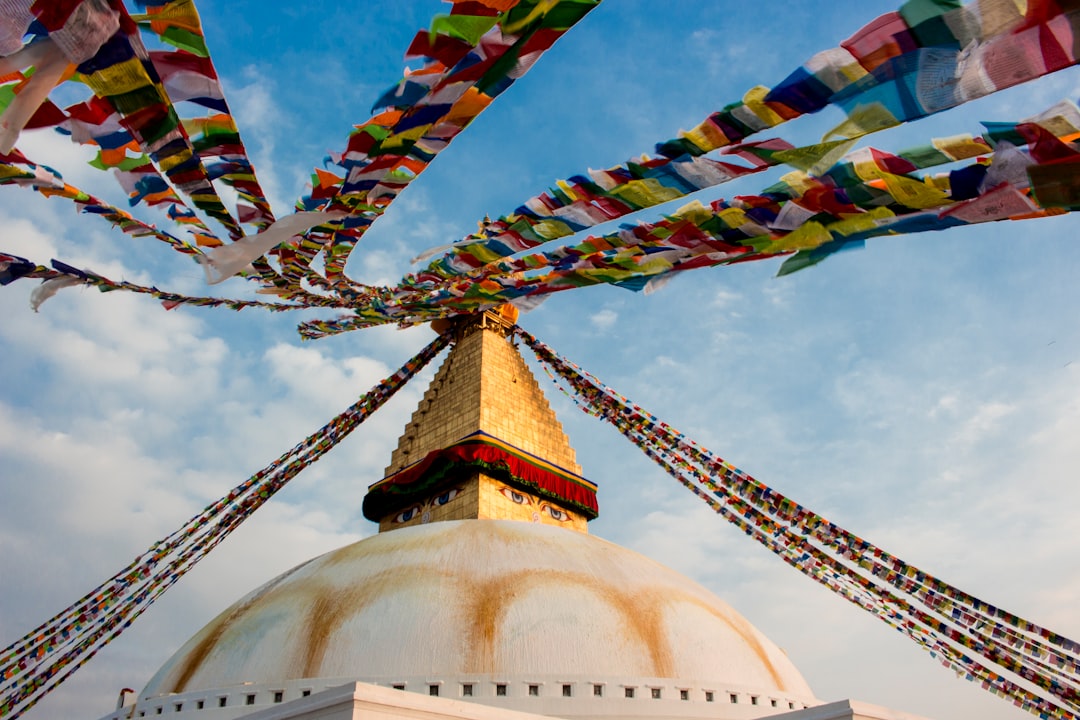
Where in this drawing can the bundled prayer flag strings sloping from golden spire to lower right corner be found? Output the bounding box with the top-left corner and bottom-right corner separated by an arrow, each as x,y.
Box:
515,328 -> 1080,720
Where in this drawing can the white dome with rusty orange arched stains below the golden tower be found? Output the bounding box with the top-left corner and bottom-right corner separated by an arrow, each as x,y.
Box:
140,520 -> 813,716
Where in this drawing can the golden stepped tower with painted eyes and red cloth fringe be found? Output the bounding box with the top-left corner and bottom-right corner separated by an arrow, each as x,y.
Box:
364,305 -> 597,531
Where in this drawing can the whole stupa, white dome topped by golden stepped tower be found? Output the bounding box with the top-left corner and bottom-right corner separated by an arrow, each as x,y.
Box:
95,308 -> 907,720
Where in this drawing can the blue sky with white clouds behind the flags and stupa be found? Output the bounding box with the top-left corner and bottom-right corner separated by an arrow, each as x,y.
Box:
0,0 -> 1080,720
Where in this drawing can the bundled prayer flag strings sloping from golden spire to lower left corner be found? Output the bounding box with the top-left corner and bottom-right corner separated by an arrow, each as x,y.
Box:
0,336 -> 449,720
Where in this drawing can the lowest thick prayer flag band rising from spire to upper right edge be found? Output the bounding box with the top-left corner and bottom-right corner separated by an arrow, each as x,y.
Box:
300,106 -> 1080,338
